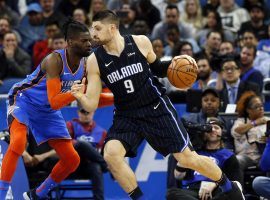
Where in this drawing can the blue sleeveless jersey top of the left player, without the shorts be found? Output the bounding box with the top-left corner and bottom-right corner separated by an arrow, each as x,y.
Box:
9,49 -> 85,107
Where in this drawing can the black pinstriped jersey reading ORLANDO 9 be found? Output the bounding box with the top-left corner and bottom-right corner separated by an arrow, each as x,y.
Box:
94,35 -> 165,111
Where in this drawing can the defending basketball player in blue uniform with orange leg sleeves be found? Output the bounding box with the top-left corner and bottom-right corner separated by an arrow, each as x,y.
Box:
0,20 -> 91,200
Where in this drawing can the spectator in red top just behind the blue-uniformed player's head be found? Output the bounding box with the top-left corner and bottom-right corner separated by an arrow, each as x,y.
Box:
32,21 -> 61,69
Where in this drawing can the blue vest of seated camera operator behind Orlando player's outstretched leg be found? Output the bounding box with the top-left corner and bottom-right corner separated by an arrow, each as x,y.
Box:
182,149 -> 233,187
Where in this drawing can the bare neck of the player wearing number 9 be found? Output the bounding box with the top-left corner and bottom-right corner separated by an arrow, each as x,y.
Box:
103,34 -> 125,57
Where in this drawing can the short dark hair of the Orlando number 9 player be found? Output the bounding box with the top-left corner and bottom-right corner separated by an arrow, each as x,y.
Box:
92,10 -> 119,28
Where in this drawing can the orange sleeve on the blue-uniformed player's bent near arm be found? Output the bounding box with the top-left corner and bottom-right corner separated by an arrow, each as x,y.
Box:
46,78 -> 75,110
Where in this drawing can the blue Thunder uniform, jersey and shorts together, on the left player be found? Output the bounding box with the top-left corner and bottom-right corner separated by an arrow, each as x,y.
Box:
7,49 -> 85,144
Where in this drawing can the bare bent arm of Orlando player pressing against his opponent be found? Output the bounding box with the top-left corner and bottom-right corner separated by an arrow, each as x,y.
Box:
71,53 -> 102,112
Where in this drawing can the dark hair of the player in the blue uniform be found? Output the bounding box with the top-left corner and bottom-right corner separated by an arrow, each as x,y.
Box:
63,18 -> 89,40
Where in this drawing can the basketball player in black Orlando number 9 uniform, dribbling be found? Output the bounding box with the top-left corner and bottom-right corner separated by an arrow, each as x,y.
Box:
71,10 -> 244,200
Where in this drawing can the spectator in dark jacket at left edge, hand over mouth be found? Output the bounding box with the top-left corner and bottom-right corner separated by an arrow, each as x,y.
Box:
0,32 -> 31,94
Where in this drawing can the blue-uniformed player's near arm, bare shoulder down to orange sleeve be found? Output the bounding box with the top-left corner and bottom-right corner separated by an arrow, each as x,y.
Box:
41,53 -> 75,110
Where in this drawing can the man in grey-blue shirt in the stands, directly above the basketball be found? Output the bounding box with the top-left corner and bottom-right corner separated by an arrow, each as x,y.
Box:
151,5 -> 195,44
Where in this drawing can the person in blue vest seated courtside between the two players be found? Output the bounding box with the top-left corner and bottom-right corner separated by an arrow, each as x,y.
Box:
67,108 -> 107,200
